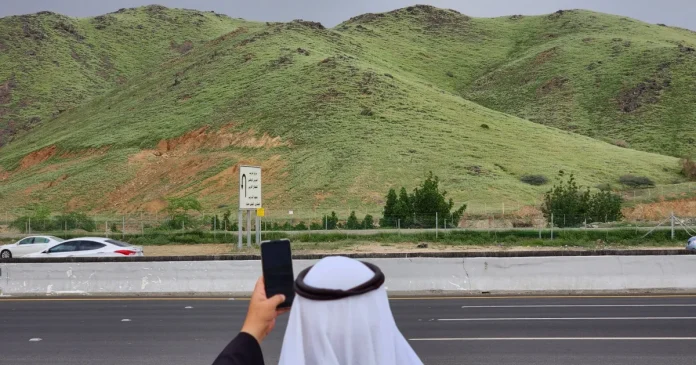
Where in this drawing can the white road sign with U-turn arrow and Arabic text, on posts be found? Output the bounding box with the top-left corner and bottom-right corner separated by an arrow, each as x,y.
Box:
237,166 -> 263,249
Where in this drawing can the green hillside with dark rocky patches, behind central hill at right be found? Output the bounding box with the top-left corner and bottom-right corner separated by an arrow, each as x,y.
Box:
336,6 -> 696,156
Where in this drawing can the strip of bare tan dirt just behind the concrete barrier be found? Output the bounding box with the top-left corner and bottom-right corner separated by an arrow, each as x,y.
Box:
139,242 -> 684,257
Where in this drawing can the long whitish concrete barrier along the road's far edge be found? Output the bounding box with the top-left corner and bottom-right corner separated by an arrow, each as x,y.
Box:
0,255 -> 696,296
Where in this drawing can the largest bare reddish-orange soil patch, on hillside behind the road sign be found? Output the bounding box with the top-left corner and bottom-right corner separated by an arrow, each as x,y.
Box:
104,124 -> 290,212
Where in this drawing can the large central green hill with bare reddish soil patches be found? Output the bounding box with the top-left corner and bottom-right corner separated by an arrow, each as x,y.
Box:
0,10 -> 676,214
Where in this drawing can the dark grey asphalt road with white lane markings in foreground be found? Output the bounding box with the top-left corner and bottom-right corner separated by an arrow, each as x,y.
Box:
0,296 -> 696,365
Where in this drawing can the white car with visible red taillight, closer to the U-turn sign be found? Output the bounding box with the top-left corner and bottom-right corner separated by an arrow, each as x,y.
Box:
24,237 -> 145,258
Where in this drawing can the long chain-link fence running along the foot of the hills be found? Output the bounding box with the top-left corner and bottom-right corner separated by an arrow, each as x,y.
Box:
0,211 -> 696,237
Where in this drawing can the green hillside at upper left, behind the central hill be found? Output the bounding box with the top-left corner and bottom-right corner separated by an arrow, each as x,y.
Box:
0,5 -> 253,146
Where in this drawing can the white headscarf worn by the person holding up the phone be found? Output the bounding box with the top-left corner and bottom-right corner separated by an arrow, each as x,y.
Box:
280,257 -> 423,365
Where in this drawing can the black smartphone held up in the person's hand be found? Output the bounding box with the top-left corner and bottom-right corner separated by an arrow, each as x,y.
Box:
261,239 -> 295,308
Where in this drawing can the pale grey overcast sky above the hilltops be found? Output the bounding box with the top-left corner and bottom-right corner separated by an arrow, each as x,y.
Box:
0,0 -> 696,30
